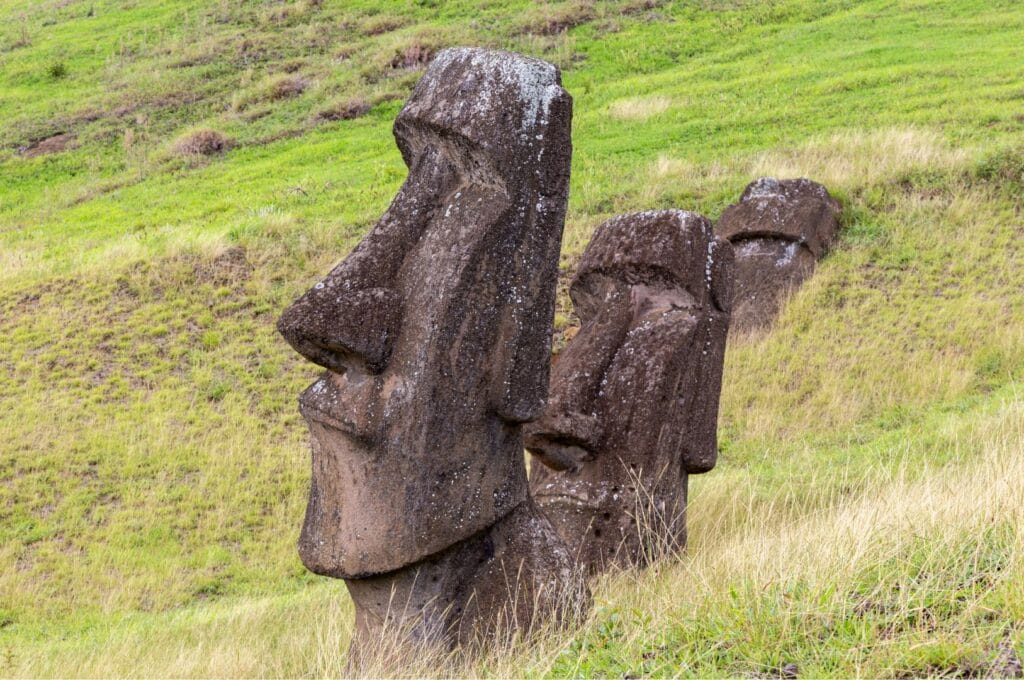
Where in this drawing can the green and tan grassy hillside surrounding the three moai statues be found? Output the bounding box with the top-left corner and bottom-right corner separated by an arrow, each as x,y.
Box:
0,0 -> 1024,676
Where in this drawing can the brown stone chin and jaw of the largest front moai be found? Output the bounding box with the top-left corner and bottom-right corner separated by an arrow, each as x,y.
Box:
299,409 -> 526,579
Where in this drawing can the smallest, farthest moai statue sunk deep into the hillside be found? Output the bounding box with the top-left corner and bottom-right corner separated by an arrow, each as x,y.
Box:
715,177 -> 841,330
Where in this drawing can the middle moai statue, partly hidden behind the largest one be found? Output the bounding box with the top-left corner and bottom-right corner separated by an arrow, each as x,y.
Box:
526,210 -> 732,573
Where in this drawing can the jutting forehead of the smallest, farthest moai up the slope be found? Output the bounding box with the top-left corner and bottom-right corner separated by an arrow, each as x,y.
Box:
716,177 -> 841,258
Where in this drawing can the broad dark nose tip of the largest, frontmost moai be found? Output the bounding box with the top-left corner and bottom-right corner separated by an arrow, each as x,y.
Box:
278,279 -> 401,373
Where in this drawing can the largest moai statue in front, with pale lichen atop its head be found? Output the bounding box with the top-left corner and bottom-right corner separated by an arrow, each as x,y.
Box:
278,49 -> 584,663
